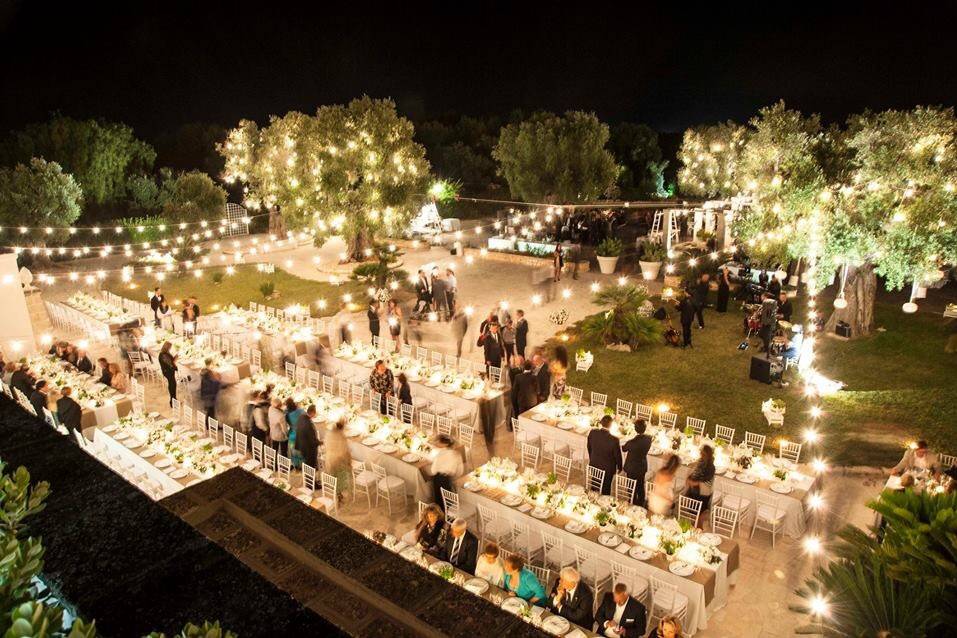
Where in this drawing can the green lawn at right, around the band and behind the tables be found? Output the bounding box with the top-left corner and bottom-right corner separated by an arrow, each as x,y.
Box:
552,288 -> 957,466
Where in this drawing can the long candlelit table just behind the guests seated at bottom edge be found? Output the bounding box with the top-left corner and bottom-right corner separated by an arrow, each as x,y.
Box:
456,459 -> 740,635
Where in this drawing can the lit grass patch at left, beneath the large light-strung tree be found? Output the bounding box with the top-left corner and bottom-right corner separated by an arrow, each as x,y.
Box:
100,265 -> 366,317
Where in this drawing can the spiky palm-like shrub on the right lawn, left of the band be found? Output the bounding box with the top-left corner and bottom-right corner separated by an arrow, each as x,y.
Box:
581,284 -> 662,349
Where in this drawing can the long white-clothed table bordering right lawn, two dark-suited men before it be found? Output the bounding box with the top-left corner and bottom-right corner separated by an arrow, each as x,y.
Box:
519,401 -> 820,538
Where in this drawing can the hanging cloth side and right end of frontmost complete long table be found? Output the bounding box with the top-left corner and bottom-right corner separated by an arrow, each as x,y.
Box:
456,474 -> 740,635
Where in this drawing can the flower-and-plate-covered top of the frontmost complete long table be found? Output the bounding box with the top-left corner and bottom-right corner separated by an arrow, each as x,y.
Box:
471,457 -> 721,565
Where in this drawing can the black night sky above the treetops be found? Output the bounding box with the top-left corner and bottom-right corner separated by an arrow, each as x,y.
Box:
0,0 -> 957,137
